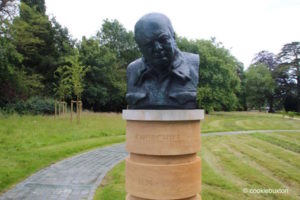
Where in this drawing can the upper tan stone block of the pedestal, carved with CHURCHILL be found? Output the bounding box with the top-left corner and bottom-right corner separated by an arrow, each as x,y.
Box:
126,121 -> 200,155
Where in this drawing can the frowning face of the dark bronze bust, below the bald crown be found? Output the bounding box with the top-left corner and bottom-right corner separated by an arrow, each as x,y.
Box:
136,23 -> 176,68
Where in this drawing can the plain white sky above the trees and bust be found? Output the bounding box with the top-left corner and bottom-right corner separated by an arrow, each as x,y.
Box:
46,0 -> 300,67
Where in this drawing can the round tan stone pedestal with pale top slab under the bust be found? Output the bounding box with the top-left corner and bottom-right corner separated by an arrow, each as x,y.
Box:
123,110 -> 204,200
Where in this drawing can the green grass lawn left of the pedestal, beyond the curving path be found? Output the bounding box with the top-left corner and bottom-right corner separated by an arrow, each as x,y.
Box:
0,113 -> 125,193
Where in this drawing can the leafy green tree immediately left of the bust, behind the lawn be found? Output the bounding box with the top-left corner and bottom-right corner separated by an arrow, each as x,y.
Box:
79,38 -> 126,111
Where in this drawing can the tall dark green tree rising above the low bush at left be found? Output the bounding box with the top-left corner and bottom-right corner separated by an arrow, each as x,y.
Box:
13,1 -> 74,95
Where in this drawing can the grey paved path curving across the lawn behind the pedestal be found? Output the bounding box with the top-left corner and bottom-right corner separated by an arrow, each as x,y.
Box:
0,130 -> 300,200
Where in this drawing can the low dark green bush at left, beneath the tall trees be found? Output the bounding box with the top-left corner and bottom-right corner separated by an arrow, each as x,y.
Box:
14,97 -> 55,115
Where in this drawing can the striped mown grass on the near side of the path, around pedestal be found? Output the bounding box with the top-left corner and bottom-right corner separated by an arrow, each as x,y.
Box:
95,130 -> 300,200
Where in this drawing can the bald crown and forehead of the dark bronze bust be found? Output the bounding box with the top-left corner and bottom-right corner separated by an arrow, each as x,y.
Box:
134,13 -> 174,42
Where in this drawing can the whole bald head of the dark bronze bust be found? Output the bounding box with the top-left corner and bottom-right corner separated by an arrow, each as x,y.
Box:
134,13 -> 176,68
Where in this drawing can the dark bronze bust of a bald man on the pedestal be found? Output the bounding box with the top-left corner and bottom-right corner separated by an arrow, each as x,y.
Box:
126,13 -> 200,109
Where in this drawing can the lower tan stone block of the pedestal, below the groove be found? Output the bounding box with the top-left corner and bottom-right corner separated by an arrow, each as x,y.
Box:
126,157 -> 201,199
